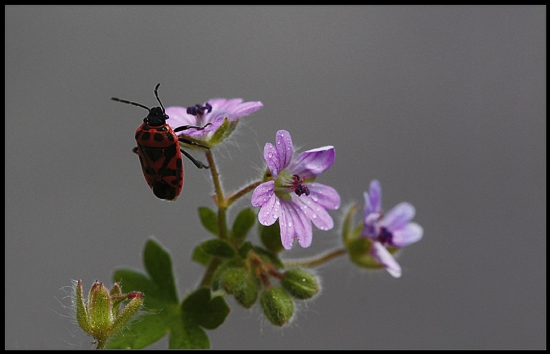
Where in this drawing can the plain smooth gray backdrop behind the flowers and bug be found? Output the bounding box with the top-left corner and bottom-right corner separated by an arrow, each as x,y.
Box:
5,6 -> 546,349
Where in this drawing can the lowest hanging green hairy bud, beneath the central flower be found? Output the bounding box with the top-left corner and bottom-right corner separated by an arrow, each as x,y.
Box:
260,286 -> 294,327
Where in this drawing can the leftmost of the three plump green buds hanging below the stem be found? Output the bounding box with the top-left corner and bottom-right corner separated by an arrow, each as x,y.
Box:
220,268 -> 260,309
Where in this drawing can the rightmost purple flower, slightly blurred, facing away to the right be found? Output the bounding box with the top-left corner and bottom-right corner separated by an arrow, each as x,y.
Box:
361,180 -> 423,278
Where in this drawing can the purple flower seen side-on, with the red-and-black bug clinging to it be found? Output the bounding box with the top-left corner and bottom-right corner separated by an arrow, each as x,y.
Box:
166,98 -> 263,146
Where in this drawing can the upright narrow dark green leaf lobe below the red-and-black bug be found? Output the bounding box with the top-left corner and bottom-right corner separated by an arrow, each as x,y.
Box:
143,239 -> 178,303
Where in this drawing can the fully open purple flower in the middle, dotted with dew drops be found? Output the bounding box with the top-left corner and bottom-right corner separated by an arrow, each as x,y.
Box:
252,130 -> 340,249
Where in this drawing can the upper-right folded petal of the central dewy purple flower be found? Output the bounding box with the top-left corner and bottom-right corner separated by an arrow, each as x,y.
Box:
288,146 -> 334,178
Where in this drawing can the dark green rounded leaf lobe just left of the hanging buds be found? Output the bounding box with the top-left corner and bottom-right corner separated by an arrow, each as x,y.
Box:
181,288 -> 230,329
